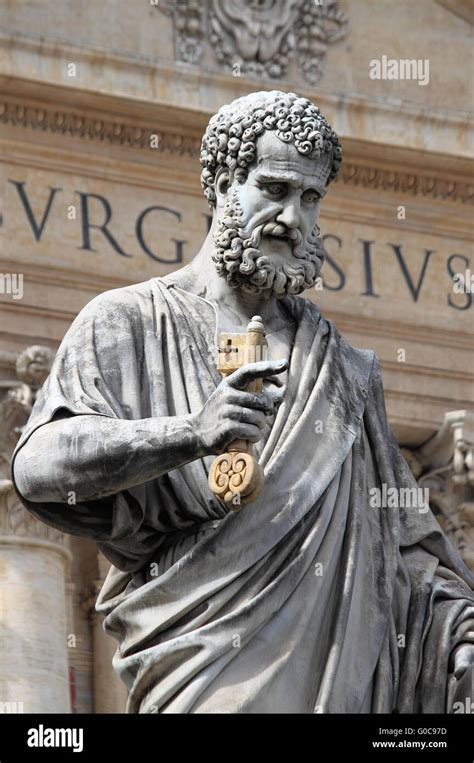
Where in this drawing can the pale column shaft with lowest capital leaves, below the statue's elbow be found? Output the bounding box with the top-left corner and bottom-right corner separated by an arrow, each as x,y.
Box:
0,481 -> 71,713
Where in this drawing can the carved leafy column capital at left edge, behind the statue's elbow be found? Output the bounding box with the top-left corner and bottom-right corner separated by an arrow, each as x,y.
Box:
0,345 -> 68,546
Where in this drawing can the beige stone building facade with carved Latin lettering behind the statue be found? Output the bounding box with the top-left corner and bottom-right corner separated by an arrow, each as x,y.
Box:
0,0 -> 474,713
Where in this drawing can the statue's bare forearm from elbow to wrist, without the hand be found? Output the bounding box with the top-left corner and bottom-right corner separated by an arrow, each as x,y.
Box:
13,415 -> 205,503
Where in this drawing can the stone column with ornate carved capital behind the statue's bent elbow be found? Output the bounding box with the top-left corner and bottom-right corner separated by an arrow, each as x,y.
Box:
0,347 -> 71,713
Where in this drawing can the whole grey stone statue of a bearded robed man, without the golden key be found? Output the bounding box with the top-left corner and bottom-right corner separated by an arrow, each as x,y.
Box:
12,91 -> 474,713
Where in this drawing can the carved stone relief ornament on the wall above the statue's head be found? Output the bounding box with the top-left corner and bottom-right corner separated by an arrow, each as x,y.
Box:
158,0 -> 348,85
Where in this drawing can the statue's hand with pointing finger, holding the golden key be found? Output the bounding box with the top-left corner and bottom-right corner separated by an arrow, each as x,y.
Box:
196,360 -> 288,455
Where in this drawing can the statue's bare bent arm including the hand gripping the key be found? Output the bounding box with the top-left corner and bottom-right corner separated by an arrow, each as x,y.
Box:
13,360 -> 288,503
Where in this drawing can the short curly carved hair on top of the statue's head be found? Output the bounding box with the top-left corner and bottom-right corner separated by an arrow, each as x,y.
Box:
200,90 -> 342,209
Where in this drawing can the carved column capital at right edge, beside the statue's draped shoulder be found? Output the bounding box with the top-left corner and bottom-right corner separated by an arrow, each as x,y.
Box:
404,411 -> 474,571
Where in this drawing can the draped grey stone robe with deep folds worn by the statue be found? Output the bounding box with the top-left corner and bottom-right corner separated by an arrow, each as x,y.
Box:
11,276 -> 474,713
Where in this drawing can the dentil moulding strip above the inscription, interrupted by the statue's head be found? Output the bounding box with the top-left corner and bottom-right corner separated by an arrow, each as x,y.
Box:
0,92 -> 474,205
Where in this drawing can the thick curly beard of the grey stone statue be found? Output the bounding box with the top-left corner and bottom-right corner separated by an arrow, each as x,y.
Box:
212,193 -> 325,299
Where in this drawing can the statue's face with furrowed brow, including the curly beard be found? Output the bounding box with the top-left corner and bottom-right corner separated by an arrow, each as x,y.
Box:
213,131 -> 331,298
